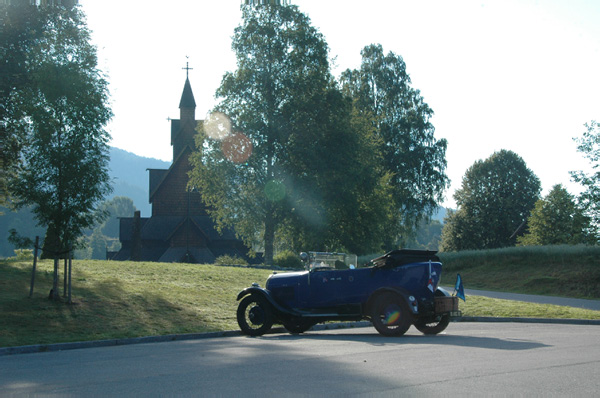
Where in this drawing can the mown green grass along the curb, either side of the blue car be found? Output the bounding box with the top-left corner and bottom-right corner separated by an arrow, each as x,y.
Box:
0,260 -> 600,347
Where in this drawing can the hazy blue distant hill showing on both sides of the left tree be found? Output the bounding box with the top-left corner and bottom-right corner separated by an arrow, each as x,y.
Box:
0,148 -> 171,257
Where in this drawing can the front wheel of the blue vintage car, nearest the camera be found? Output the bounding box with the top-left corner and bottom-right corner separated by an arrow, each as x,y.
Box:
237,294 -> 273,336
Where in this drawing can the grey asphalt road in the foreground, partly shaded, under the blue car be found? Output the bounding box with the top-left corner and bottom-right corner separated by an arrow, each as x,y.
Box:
0,323 -> 600,397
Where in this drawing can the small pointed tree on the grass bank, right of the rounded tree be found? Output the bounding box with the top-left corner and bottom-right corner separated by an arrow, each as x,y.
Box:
518,184 -> 595,246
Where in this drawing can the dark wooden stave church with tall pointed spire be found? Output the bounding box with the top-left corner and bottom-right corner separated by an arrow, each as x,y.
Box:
107,75 -> 254,264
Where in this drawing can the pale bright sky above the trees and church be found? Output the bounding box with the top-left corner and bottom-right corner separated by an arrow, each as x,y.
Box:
79,0 -> 600,207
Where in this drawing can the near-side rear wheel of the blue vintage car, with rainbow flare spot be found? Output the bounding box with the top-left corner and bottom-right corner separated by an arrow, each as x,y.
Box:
371,292 -> 412,337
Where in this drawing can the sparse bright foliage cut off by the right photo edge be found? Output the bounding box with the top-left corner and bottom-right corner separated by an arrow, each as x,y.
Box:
571,120 -> 600,228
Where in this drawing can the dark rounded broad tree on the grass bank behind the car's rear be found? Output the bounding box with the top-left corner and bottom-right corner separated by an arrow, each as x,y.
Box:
441,150 -> 541,251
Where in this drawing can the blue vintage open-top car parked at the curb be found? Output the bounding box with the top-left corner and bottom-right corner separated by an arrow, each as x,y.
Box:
237,249 -> 458,336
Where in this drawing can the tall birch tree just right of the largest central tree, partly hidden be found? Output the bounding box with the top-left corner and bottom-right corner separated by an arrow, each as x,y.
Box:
341,44 -> 449,248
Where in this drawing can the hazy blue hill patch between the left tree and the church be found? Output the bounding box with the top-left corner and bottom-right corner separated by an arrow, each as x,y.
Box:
107,148 -> 171,217
